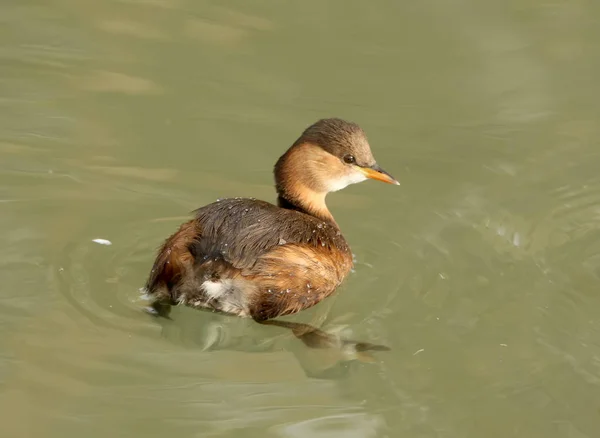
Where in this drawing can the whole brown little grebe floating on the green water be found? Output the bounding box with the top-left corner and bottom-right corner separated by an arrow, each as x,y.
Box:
146,118 -> 399,323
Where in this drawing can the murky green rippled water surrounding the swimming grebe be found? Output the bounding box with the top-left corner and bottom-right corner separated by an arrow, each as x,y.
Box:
0,0 -> 600,438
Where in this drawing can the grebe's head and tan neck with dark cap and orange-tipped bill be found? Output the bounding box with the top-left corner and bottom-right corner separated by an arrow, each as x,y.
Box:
275,118 -> 400,219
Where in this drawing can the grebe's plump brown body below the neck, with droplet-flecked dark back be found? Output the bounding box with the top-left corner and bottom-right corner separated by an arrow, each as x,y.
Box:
147,198 -> 352,320
